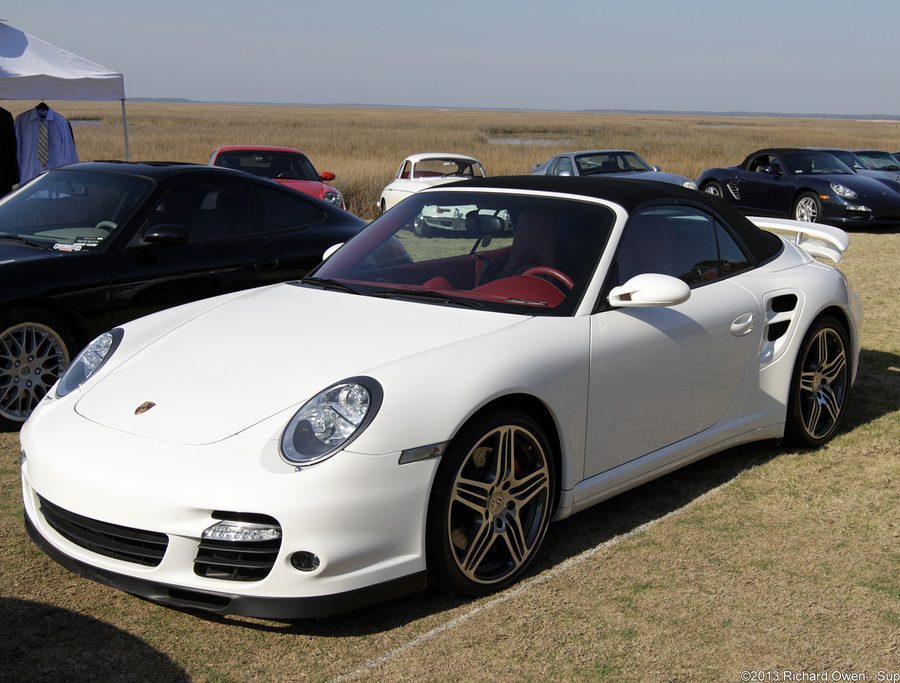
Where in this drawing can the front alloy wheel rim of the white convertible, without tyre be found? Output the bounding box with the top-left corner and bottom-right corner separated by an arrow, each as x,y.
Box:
446,425 -> 552,585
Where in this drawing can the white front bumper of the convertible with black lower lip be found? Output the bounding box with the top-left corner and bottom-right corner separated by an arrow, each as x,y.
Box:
21,405 -> 438,619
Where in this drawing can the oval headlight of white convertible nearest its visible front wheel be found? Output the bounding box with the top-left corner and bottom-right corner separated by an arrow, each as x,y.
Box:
281,377 -> 382,465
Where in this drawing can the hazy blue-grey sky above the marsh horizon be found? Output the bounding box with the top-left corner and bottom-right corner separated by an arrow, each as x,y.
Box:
7,0 -> 900,115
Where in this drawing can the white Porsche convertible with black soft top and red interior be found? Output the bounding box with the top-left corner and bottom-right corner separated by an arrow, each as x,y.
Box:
21,177 -> 861,618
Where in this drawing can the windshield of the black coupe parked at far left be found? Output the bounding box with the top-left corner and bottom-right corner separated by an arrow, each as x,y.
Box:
0,169 -> 153,251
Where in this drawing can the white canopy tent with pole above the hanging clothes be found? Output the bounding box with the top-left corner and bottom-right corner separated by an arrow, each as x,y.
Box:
0,20 -> 129,160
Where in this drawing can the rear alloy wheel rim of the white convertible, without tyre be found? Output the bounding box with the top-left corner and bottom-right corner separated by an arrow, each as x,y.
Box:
799,327 -> 847,439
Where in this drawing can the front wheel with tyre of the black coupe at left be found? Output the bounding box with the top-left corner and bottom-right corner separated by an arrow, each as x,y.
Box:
0,308 -> 74,430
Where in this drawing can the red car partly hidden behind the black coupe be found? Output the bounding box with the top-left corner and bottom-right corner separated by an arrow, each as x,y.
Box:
209,145 -> 347,209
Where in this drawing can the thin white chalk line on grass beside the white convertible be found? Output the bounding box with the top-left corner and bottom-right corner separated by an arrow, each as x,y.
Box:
332,481 -> 731,683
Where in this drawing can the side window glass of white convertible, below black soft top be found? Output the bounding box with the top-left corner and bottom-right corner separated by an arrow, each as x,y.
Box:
615,206 -> 750,287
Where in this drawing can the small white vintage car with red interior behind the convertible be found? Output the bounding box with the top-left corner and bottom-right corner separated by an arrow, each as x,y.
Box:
378,152 -> 487,213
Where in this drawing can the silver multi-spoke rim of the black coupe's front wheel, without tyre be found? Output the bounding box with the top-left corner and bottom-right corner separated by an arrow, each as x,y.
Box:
0,322 -> 69,422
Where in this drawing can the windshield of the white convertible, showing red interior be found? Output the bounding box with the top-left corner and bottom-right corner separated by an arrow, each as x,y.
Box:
303,190 -> 615,315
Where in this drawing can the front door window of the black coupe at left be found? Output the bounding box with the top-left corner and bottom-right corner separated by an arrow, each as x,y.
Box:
145,180 -> 254,242
